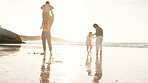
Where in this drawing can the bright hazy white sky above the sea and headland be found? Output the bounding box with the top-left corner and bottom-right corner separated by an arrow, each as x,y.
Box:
0,0 -> 148,42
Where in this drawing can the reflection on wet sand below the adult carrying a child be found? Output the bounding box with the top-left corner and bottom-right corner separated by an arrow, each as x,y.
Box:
40,55 -> 52,83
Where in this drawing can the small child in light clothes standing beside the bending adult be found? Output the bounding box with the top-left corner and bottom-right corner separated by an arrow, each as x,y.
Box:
86,32 -> 93,53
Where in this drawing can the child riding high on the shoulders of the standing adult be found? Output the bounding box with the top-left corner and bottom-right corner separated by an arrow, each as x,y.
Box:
41,1 -> 53,27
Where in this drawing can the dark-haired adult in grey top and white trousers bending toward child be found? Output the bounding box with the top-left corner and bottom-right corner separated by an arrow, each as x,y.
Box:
93,24 -> 103,56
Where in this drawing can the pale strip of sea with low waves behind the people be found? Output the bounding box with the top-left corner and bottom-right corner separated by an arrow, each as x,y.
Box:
0,41 -> 148,48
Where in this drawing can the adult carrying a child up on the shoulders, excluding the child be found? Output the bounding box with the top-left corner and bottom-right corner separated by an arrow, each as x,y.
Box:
41,11 -> 54,55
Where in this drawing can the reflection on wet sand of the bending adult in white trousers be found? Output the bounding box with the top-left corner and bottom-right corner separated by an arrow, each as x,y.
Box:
92,57 -> 102,83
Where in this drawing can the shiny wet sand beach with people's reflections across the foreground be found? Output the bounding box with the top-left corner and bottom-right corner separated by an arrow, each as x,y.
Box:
0,43 -> 148,83
